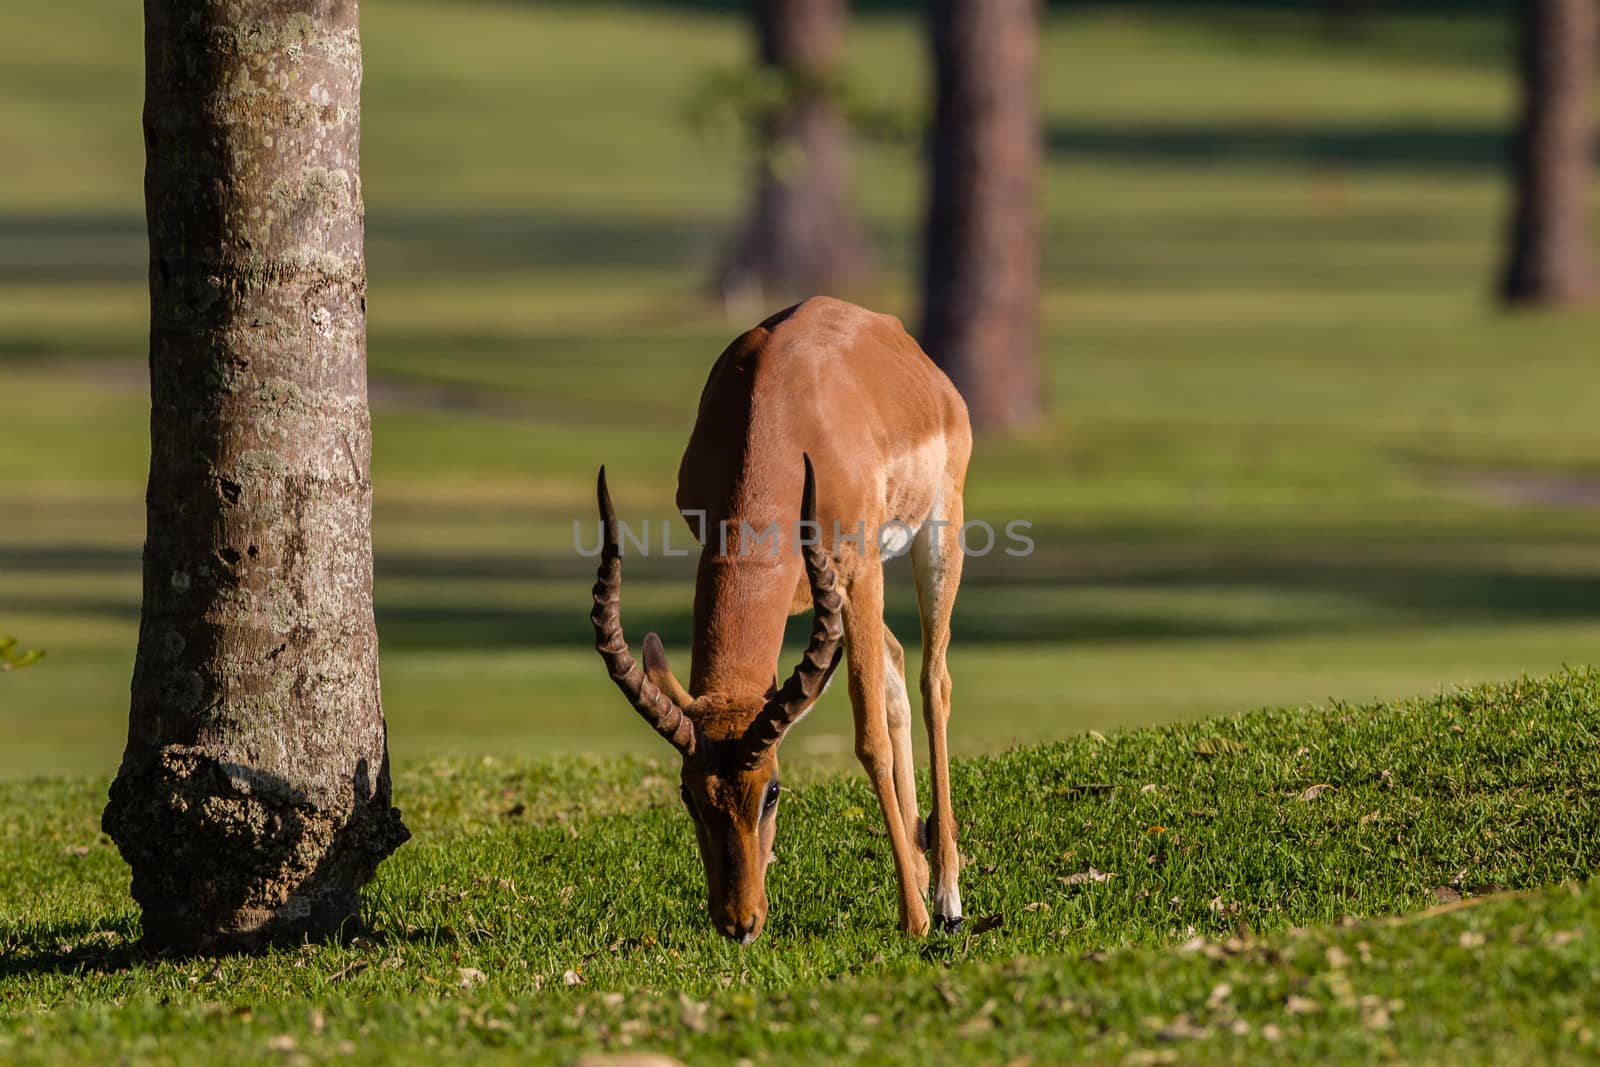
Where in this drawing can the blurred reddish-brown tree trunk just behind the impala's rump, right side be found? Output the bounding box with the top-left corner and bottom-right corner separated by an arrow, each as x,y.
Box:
922,0 -> 1045,430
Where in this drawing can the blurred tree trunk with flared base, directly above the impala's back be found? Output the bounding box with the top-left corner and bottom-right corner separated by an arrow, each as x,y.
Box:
718,0 -> 872,304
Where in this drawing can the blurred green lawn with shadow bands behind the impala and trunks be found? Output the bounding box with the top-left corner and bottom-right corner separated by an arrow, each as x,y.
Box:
0,0 -> 1600,776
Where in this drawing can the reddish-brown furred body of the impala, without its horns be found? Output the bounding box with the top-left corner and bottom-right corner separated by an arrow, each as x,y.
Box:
630,298 -> 971,941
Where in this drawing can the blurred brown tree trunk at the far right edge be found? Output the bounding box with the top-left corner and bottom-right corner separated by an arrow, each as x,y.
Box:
1501,0 -> 1600,304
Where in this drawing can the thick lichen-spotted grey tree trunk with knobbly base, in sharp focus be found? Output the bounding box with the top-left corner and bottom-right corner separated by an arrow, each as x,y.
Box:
104,0 -> 408,952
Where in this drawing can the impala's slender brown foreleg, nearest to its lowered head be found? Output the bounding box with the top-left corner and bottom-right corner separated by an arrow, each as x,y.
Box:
845,566 -> 928,936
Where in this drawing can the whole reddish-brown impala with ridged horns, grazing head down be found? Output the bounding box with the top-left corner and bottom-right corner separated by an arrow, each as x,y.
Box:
594,298 -> 971,944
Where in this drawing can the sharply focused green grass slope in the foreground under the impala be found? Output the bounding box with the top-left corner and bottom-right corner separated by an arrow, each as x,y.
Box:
0,672 -> 1600,1064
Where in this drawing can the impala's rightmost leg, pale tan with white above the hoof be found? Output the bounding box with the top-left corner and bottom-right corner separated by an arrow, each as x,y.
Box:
912,480 -> 963,929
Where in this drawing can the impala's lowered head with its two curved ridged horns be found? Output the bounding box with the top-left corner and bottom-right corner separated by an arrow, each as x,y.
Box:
590,458 -> 843,944
